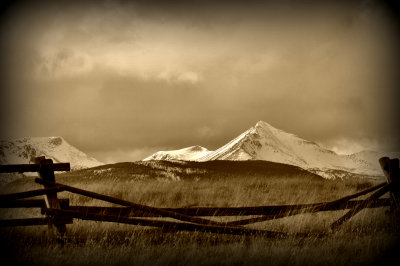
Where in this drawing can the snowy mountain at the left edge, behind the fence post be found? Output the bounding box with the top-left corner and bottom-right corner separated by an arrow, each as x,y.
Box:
0,137 -> 103,170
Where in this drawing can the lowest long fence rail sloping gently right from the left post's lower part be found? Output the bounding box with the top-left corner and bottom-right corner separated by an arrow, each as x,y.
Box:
46,209 -> 318,238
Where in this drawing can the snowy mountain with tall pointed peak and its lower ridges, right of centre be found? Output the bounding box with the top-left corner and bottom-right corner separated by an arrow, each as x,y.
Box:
144,121 -> 400,178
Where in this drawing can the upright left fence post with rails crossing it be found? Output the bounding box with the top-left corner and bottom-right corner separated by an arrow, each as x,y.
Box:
35,156 -> 67,238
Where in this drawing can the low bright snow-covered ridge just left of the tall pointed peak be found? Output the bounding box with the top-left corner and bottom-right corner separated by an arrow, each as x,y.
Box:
143,146 -> 211,161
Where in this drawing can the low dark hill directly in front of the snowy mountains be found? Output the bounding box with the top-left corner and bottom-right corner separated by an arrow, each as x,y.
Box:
59,161 -> 322,182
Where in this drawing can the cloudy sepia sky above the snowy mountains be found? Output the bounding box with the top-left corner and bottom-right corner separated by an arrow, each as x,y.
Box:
0,0 -> 400,163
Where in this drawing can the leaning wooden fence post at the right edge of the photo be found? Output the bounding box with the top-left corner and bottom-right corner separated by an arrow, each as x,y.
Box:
379,157 -> 400,209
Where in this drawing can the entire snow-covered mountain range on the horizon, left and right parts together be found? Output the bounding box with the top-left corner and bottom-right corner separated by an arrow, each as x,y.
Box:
0,121 -> 400,181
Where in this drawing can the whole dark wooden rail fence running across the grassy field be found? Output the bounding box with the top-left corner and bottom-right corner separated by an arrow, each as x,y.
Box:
0,157 -> 400,237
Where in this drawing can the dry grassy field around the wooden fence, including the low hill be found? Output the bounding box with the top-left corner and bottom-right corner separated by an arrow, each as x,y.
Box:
0,160 -> 400,265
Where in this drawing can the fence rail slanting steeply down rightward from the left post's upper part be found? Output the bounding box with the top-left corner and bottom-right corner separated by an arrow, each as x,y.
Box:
35,178 -> 233,226
